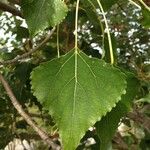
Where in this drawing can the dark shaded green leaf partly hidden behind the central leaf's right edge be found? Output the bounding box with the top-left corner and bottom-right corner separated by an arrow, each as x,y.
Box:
95,73 -> 139,150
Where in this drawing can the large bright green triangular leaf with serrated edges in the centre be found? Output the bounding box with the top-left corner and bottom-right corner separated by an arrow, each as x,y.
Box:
31,51 -> 126,150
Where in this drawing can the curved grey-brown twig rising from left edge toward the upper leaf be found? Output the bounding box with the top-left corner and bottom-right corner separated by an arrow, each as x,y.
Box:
0,27 -> 55,65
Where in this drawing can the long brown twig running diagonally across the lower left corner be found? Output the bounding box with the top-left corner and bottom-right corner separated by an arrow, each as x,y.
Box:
0,74 -> 60,150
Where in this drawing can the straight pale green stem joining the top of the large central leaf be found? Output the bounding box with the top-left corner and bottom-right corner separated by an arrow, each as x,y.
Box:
74,0 -> 80,53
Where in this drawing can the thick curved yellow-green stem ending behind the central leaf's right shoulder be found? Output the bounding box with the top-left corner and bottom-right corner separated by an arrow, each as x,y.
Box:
97,0 -> 114,64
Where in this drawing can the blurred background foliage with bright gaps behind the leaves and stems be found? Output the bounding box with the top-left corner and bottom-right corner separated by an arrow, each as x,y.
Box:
0,0 -> 150,150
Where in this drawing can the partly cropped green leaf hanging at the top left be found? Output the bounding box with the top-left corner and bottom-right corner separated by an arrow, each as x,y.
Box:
21,0 -> 67,36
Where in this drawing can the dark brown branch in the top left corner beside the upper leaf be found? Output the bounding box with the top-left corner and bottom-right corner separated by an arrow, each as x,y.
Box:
0,2 -> 23,18
